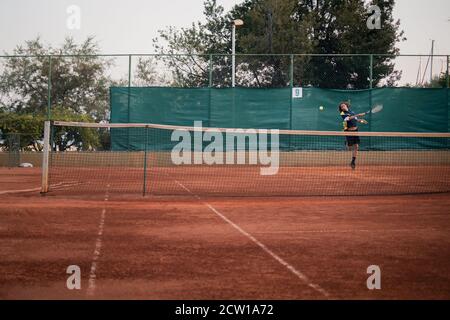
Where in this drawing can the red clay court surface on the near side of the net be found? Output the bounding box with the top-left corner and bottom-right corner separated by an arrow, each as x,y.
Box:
0,168 -> 450,299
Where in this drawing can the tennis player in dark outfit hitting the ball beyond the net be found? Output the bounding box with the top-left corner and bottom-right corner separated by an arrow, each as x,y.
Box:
339,102 -> 367,169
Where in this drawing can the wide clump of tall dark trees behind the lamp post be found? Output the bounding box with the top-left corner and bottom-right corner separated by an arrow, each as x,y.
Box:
150,0 -> 404,88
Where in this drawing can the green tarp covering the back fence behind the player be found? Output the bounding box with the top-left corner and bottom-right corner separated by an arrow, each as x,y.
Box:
110,87 -> 450,150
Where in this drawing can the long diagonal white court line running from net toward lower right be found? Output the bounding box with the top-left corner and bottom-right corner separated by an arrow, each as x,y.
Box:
175,180 -> 330,298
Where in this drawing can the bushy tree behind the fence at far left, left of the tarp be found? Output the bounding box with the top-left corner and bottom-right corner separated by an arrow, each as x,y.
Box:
0,37 -> 112,120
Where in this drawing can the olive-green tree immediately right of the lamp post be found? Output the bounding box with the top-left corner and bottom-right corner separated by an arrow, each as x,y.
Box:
231,0 -> 313,87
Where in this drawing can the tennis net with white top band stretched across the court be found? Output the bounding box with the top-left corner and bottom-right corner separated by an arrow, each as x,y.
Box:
42,122 -> 450,196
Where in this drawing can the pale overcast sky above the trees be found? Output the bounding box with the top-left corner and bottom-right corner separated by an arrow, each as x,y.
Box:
0,0 -> 450,81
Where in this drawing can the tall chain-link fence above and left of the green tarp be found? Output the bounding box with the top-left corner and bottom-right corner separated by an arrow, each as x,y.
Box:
0,54 -> 450,166
